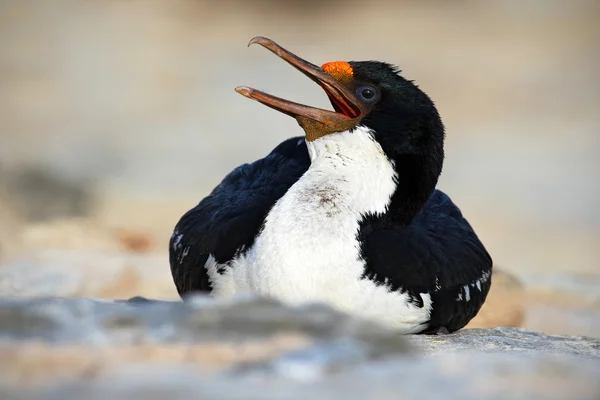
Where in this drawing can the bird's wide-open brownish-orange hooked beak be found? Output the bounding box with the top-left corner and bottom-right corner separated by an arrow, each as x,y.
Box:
235,36 -> 362,138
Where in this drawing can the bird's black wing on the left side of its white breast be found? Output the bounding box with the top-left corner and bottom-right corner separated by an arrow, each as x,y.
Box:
169,137 -> 310,295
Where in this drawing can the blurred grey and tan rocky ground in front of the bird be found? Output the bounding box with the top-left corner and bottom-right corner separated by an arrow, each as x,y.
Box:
0,297 -> 600,399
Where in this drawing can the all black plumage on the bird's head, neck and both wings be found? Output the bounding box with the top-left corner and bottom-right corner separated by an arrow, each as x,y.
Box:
169,55 -> 492,333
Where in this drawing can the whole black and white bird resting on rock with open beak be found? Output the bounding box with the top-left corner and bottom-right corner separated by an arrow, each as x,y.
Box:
169,37 -> 492,334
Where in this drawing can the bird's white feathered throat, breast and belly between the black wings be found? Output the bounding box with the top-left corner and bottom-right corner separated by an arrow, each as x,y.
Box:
206,127 -> 431,333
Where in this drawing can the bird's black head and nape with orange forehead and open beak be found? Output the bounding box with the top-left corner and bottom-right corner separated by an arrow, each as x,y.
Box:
236,37 -> 444,222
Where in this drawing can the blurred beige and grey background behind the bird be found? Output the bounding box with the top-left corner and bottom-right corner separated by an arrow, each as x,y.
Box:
0,0 -> 600,336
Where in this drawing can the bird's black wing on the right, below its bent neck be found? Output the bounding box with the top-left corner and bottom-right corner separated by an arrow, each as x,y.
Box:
359,190 -> 492,332
